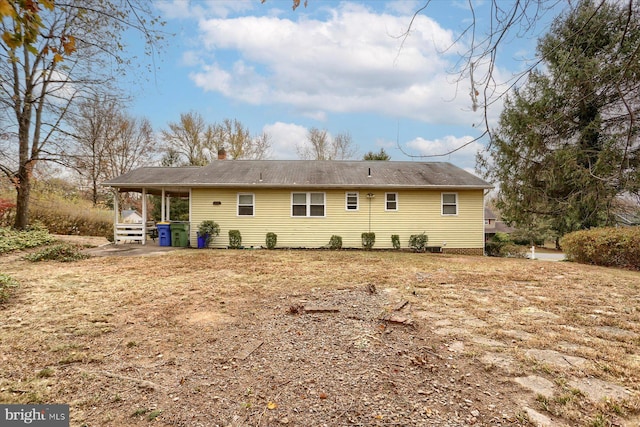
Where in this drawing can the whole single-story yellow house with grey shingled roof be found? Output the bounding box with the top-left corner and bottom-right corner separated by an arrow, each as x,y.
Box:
104,160 -> 492,255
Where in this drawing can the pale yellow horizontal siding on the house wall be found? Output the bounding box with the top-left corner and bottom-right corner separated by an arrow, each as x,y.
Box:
190,188 -> 484,254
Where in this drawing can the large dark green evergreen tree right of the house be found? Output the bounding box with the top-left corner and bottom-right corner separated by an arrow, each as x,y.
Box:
479,1 -> 640,246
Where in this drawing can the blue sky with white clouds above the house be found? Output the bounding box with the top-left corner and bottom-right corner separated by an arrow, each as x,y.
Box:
131,0 -> 552,170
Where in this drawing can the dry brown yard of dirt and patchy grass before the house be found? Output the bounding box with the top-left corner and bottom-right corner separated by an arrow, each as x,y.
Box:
0,242 -> 640,427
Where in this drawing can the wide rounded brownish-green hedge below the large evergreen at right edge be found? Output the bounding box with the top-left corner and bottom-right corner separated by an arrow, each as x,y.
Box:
560,227 -> 640,270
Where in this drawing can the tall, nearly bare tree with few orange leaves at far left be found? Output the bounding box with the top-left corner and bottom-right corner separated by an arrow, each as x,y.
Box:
0,0 -> 164,229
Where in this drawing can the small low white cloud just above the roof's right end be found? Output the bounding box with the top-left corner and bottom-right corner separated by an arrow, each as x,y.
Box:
405,135 -> 485,171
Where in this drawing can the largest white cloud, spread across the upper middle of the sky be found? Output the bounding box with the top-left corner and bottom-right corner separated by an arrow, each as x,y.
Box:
185,3 -> 480,125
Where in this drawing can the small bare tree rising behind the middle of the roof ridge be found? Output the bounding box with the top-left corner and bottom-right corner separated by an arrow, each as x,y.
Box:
296,127 -> 357,160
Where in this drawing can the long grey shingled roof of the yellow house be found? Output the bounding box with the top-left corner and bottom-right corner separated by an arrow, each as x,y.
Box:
103,160 -> 492,191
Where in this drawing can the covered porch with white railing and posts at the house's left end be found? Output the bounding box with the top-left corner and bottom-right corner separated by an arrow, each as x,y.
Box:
113,187 -> 191,245
